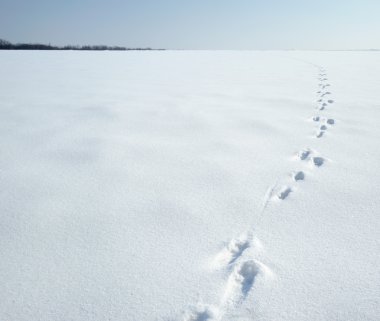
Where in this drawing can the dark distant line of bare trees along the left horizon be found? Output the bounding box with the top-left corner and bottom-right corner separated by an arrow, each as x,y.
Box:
0,39 -> 163,51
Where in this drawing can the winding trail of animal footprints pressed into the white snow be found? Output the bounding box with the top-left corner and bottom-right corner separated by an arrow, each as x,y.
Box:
180,68 -> 335,321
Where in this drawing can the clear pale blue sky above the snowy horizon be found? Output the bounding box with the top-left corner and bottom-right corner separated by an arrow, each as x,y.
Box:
0,0 -> 380,49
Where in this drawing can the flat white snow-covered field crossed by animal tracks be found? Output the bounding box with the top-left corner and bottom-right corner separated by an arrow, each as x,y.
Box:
0,51 -> 380,321
